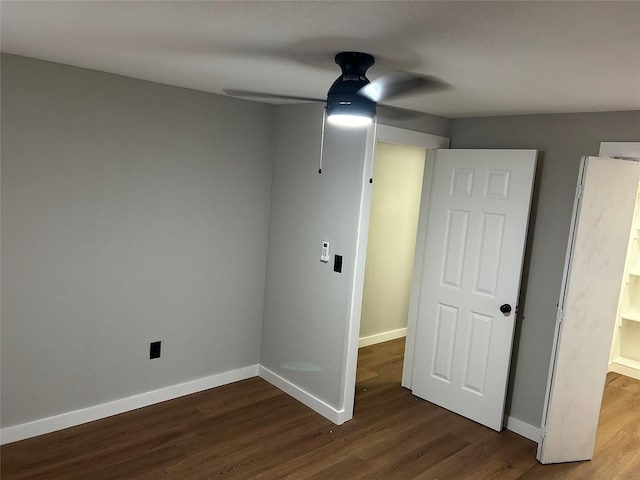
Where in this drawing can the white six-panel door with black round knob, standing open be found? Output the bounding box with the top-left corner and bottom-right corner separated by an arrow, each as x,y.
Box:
411,150 -> 536,431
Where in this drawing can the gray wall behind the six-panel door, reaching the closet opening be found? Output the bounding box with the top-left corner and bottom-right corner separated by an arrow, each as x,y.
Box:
451,111 -> 640,426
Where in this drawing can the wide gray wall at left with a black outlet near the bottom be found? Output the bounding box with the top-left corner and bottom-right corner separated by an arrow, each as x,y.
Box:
1,55 -> 276,426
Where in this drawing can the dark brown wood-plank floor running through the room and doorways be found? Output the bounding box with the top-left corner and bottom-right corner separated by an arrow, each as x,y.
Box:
1,340 -> 640,480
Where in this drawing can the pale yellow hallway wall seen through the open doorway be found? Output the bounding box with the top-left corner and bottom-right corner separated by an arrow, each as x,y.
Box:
360,142 -> 425,338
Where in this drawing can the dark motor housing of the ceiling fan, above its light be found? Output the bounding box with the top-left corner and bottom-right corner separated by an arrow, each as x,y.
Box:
327,52 -> 376,118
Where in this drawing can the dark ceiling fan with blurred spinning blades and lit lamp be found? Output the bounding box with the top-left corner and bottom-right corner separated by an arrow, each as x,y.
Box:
224,52 -> 447,126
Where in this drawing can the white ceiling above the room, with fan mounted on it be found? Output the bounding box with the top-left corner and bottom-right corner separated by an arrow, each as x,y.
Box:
0,0 -> 640,118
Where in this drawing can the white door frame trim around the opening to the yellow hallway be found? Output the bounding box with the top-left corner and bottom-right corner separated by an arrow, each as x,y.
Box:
339,124 -> 450,423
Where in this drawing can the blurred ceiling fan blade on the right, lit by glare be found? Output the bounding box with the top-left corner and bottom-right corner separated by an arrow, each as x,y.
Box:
358,72 -> 451,102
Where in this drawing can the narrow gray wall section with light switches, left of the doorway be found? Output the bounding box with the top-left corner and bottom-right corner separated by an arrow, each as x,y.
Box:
261,105 -> 450,410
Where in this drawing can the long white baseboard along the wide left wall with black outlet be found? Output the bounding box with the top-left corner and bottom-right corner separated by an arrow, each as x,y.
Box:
0,365 -> 258,445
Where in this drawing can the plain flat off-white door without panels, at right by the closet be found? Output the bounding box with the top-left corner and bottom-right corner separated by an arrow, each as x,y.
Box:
538,157 -> 640,463
